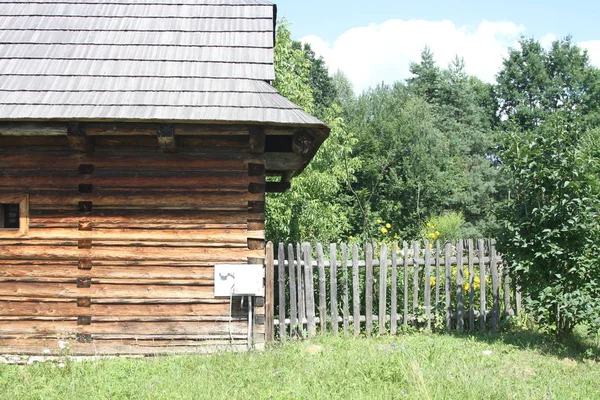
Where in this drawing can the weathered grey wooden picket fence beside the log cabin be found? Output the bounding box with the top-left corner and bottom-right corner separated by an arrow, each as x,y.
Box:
265,239 -> 521,341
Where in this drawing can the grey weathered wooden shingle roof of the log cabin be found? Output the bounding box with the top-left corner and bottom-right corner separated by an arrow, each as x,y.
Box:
0,0 -> 324,127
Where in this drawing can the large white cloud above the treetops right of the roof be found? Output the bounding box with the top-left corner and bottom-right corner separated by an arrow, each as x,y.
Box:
301,19 -> 524,93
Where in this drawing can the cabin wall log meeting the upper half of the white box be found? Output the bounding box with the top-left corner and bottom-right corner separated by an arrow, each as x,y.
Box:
0,263 -> 214,284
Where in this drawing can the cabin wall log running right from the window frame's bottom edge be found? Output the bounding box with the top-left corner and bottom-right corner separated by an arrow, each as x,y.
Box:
0,228 -> 253,245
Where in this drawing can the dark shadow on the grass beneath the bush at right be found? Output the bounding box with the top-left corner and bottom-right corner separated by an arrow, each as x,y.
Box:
453,329 -> 600,361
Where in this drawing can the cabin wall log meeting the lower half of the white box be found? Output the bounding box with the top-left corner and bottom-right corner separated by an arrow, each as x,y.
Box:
0,282 -> 214,299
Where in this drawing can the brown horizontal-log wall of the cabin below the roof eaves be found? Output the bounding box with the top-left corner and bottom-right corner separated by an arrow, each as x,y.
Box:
0,125 -> 265,354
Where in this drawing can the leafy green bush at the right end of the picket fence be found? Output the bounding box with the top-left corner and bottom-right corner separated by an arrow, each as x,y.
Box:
498,120 -> 600,333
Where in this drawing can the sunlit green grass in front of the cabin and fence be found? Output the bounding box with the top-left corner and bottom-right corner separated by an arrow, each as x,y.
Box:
0,333 -> 600,400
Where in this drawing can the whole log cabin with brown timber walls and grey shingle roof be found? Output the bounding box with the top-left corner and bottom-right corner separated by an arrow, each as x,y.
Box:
0,0 -> 329,354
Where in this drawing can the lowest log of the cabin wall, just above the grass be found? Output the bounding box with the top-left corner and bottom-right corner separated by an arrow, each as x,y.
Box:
0,335 -> 248,354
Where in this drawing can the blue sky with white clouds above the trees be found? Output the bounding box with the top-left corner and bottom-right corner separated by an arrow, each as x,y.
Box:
275,0 -> 600,92
